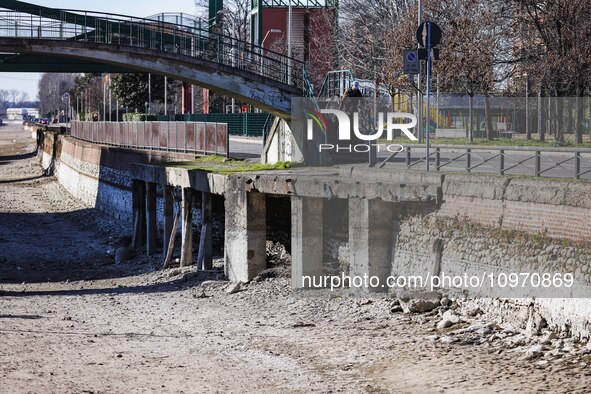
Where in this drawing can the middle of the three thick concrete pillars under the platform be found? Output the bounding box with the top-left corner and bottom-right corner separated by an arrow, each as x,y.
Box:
291,197 -> 324,289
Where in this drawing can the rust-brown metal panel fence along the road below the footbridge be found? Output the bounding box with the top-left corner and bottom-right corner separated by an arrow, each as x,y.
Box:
71,121 -> 229,157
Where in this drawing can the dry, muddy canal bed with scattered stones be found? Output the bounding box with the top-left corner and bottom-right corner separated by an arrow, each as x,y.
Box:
0,125 -> 591,393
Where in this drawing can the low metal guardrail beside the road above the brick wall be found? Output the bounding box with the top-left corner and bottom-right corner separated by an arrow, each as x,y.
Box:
378,144 -> 591,179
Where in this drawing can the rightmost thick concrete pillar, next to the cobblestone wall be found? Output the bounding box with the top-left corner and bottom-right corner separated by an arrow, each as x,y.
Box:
349,197 -> 400,292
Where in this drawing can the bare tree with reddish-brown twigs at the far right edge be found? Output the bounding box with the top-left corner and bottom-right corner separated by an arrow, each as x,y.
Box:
506,0 -> 591,143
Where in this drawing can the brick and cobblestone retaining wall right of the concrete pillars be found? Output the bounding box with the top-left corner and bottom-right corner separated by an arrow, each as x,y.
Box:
392,174 -> 591,338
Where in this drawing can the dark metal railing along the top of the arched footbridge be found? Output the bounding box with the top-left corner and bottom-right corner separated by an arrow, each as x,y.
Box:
0,7 -> 304,89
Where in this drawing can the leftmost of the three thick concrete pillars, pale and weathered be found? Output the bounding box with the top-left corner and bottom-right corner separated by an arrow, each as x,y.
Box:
224,190 -> 267,282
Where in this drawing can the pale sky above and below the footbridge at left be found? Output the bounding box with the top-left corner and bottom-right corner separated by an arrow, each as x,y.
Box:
0,0 -> 197,99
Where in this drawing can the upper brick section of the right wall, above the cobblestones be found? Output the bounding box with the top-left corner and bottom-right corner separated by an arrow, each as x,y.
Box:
437,175 -> 591,241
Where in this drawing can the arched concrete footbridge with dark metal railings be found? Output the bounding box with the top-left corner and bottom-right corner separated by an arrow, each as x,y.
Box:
0,0 -> 305,119
